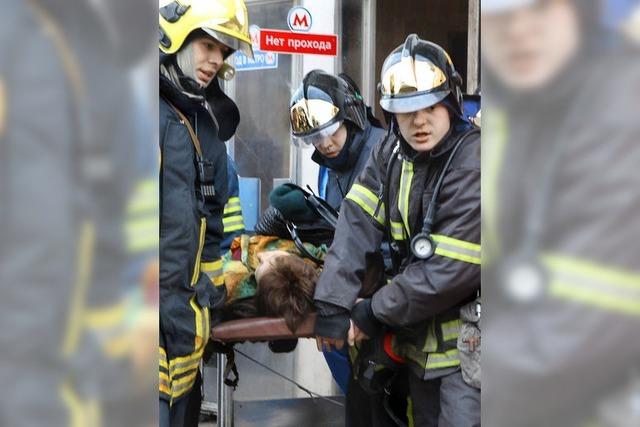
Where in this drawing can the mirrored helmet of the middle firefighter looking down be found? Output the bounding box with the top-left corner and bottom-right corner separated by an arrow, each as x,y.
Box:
289,70 -> 367,145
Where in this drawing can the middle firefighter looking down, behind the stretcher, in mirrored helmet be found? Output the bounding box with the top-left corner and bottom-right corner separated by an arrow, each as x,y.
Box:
289,70 -> 384,402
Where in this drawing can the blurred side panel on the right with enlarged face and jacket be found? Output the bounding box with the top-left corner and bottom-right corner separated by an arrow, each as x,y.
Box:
481,0 -> 640,427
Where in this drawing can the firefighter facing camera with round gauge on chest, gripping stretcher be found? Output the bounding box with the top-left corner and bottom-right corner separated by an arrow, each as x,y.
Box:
315,34 -> 480,426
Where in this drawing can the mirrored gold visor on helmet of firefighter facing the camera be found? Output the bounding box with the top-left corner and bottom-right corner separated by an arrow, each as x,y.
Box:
381,55 -> 447,97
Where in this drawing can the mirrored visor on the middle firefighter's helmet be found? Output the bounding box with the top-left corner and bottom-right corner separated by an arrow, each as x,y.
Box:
290,98 -> 340,137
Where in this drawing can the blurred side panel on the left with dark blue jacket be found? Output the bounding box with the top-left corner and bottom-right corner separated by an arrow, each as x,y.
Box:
0,0 -> 159,426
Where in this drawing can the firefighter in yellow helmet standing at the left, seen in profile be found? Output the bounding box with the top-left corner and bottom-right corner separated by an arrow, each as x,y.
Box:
159,0 -> 252,426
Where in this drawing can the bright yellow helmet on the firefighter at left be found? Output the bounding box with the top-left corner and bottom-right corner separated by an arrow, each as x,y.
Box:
159,0 -> 253,58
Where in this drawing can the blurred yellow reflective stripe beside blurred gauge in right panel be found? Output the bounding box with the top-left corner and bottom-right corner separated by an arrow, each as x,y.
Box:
543,254 -> 640,316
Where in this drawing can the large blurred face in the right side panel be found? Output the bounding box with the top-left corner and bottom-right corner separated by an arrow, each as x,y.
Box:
482,0 -> 580,91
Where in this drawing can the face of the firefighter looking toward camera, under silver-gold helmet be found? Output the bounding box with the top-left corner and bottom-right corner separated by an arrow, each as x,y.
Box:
396,104 -> 451,152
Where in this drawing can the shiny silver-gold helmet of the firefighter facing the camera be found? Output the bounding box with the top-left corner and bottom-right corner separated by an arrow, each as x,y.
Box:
378,34 -> 462,116
